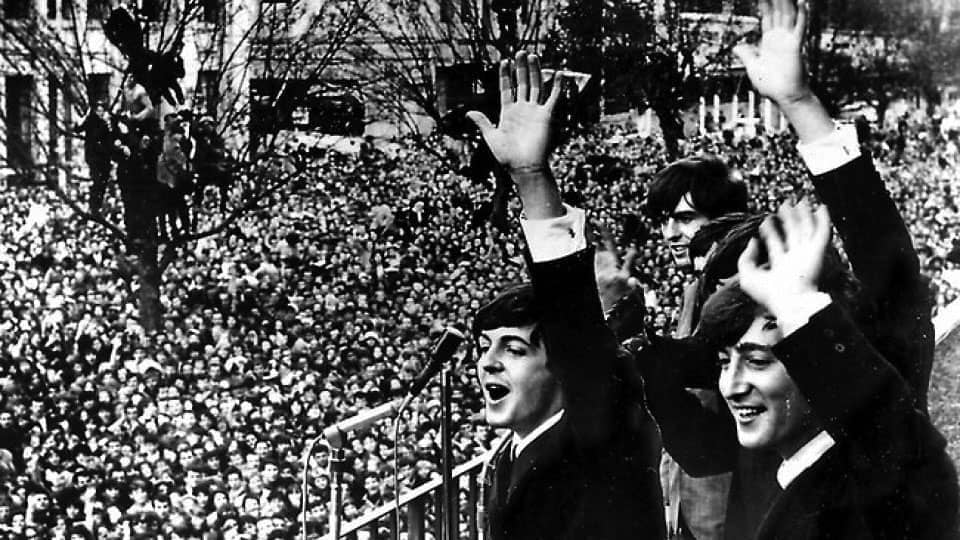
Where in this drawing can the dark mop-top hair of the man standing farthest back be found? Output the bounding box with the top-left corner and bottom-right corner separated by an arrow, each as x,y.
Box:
647,154 -> 747,219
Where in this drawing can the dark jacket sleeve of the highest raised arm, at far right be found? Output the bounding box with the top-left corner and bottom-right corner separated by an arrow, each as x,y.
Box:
813,154 -> 933,410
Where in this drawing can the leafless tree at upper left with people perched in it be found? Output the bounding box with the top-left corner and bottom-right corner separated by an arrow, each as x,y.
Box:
0,0 -> 375,330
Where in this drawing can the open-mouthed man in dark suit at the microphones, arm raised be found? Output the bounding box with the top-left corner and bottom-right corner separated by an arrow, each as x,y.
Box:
469,52 -> 665,540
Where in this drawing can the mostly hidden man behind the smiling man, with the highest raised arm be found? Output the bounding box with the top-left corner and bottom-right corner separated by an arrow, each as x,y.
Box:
641,0 -> 952,539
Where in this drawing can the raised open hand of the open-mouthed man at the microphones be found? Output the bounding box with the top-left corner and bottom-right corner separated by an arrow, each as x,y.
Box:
467,51 -> 562,175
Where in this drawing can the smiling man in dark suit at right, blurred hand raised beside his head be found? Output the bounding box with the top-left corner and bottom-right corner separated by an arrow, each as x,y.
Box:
692,202 -> 958,540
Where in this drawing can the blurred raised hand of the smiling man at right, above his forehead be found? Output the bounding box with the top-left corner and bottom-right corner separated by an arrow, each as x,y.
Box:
737,200 -> 831,318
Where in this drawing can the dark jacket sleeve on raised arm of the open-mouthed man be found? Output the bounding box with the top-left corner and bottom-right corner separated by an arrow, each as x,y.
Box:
531,248 -> 618,446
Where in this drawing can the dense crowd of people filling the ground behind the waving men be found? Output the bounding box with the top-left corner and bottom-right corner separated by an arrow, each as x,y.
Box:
0,108 -> 960,540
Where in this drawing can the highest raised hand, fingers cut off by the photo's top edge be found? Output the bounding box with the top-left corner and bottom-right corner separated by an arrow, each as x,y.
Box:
733,0 -> 812,106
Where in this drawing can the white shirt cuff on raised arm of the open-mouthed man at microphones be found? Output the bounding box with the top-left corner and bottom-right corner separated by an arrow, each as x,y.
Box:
520,204 -> 587,262
